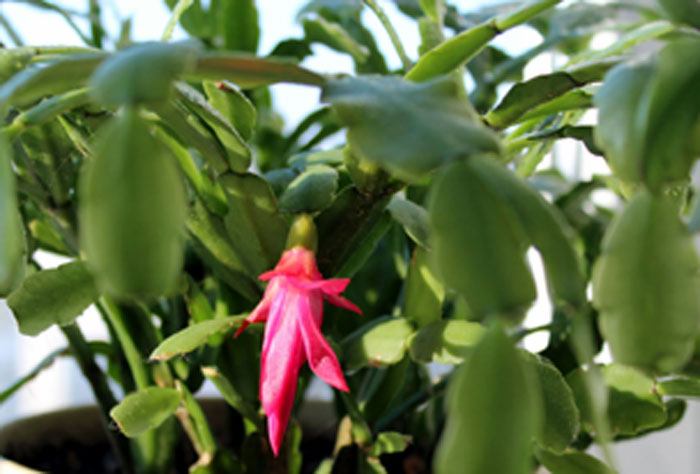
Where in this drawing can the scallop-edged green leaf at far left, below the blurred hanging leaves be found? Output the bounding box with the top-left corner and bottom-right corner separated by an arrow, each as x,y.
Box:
7,262 -> 100,336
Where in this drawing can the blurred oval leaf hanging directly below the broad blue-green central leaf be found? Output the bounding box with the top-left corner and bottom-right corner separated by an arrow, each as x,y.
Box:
428,157 -> 535,321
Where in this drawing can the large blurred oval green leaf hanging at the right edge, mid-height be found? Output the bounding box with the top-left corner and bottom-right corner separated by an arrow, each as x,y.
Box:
592,190 -> 700,374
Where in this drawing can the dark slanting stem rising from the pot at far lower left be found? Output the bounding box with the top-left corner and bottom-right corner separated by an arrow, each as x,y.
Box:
61,323 -> 134,473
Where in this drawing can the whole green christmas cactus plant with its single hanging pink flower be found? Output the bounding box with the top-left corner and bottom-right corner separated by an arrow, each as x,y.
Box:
0,0 -> 700,474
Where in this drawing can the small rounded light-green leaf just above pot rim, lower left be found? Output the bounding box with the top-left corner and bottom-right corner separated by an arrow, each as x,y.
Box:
109,387 -> 180,438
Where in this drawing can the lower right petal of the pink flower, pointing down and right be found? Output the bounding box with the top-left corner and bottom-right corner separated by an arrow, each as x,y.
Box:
298,292 -> 350,392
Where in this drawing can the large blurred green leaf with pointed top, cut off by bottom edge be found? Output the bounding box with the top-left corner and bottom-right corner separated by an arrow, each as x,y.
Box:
434,324 -> 541,474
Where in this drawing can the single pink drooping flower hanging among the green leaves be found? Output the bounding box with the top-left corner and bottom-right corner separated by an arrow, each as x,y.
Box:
236,247 -> 362,456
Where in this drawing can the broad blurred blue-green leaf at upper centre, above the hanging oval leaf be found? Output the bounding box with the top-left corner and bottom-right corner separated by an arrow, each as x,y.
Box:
322,77 -> 500,181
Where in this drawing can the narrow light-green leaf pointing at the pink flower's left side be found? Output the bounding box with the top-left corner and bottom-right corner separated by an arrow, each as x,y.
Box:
150,316 -> 245,360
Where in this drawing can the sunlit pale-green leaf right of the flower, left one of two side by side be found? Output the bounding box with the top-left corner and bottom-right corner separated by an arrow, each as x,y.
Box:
343,316 -> 413,370
